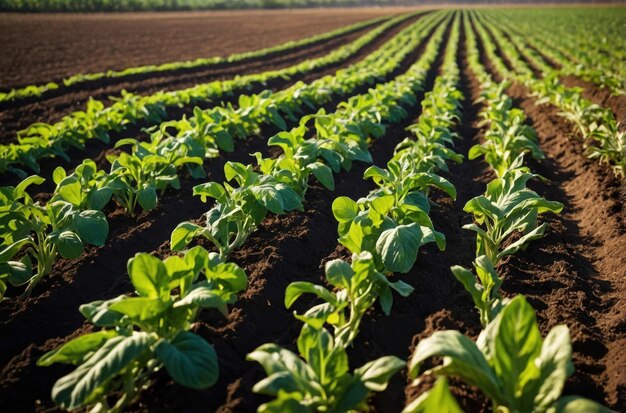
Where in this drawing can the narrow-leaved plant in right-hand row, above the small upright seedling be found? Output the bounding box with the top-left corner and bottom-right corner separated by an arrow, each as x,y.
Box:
463,156 -> 563,264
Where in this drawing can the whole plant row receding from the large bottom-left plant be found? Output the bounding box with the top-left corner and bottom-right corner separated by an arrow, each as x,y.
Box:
30,16 -> 445,411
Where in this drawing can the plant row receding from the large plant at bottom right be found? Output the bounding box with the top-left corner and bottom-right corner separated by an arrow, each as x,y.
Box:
404,20 -> 609,413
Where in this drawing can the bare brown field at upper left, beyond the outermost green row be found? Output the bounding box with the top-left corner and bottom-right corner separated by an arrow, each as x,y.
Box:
0,8 -> 398,88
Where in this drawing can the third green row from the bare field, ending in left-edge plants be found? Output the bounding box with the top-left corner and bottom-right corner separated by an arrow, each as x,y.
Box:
0,12 -> 439,297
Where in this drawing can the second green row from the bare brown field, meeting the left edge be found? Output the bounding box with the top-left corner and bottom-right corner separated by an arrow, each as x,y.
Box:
0,14 -> 422,175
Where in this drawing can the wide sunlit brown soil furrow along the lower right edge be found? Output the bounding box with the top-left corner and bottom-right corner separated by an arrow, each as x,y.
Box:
472,18 -> 626,409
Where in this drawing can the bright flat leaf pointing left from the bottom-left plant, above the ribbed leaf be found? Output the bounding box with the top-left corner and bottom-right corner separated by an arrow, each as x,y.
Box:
37,330 -> 117,366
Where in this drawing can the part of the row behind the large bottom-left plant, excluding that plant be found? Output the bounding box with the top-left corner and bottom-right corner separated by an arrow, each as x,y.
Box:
171,15 -> 443,258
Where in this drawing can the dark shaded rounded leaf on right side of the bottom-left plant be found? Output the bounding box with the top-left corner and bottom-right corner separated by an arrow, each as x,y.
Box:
156,331 -> 219,389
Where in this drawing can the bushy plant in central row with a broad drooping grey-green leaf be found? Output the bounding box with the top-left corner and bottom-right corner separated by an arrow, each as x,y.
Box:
332,158 -> 456,273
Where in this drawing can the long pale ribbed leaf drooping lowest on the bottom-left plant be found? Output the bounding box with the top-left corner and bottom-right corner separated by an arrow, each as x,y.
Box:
52,332 -> 154,410
